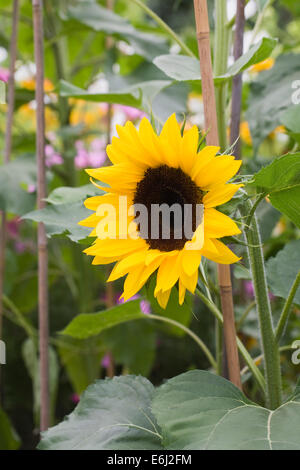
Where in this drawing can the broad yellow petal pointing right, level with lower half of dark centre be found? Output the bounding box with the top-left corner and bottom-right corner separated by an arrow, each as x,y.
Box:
204,208 -> 241,238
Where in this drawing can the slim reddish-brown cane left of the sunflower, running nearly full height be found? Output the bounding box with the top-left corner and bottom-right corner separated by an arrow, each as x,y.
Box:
32,0 -> 49,431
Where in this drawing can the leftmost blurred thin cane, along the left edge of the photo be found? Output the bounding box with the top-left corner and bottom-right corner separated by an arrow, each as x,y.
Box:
0,0 -> 19,390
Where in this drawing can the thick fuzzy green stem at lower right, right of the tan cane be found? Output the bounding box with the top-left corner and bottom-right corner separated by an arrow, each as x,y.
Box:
240,200 -> 281,409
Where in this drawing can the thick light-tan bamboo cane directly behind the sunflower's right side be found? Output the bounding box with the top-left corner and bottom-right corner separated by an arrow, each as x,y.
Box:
194,0 -> 242,389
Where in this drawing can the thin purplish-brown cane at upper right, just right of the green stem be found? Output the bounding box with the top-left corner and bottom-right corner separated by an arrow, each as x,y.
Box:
230,0 -> 245,158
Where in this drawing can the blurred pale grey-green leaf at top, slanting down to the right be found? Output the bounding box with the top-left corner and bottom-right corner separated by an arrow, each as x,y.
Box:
67,1 -> 168,61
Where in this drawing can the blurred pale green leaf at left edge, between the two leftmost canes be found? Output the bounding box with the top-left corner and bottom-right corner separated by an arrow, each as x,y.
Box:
0,155 -> 37,215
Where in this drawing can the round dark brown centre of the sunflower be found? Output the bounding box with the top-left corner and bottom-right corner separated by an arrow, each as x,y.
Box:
133,165 -> 203,251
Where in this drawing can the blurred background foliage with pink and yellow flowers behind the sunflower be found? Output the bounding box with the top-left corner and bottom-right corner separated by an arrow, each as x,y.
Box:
0,0 -> 300,449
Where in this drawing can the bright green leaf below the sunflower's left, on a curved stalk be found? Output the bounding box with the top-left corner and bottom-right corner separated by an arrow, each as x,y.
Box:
62,300 -> 145,339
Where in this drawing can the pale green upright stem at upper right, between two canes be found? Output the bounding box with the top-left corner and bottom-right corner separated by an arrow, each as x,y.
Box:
214,0 -> 230,151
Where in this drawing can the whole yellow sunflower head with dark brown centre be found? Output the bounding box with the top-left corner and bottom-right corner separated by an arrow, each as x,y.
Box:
80,114 -> 242,308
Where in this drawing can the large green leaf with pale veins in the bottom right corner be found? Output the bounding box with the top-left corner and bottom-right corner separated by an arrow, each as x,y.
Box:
152,370 -> 300,450
